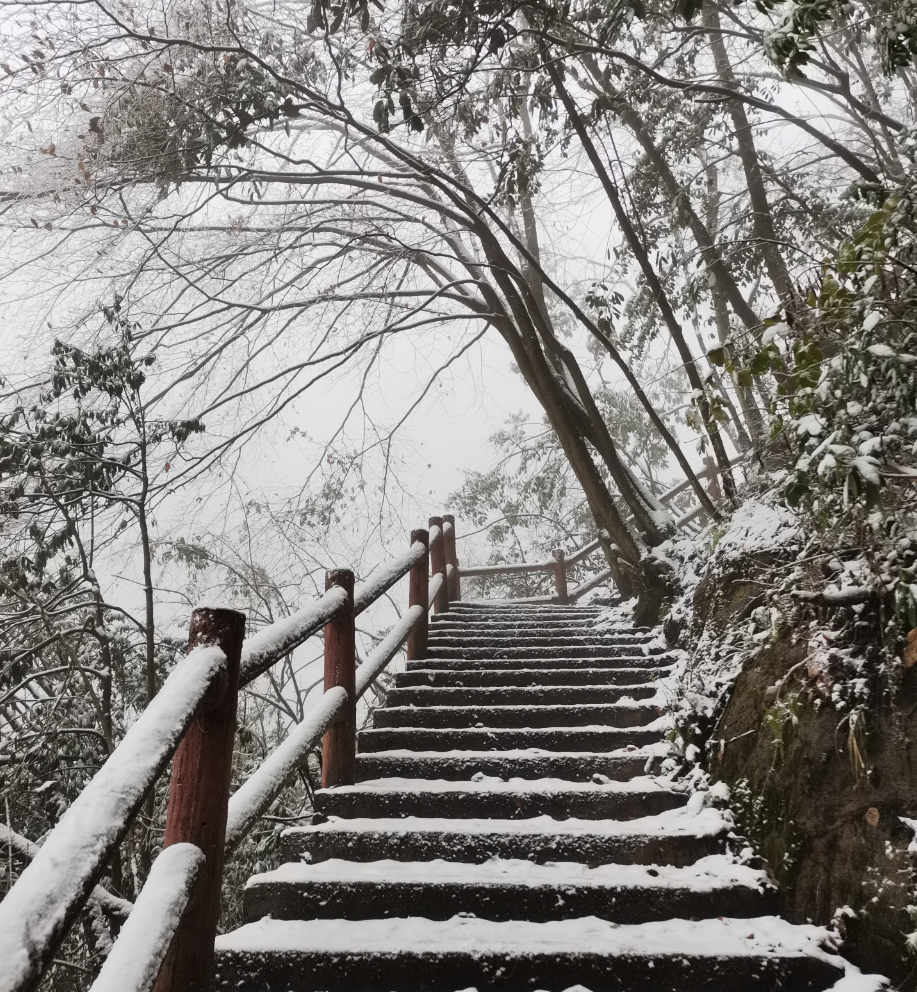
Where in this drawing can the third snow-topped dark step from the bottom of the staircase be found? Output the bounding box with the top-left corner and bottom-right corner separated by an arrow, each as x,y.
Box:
281,808 -> 729,868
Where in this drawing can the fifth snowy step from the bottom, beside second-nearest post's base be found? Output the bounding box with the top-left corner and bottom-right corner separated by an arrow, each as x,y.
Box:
357,748 -> 661,782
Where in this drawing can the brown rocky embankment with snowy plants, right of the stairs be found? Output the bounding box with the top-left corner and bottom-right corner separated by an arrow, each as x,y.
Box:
665,502 -> 917,990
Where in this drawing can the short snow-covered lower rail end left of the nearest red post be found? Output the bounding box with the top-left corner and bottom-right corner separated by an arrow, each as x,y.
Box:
89,844 -> 204,992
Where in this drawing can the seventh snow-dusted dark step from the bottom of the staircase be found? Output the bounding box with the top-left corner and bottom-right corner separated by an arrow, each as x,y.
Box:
373,703 -> 663,730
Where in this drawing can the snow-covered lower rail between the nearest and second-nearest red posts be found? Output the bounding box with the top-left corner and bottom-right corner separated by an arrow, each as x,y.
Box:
226,686 -> 347,857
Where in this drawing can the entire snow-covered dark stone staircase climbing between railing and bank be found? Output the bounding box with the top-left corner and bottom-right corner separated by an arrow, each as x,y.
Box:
217,603 -> 842,992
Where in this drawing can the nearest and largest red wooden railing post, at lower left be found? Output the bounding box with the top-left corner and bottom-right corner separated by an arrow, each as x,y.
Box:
154,609 -> 245,992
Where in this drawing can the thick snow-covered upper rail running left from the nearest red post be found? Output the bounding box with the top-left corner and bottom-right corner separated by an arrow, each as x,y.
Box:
0,646 -> 226,992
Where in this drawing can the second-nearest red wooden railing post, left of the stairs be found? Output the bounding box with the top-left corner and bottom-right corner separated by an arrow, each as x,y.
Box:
322,568 -> 357,789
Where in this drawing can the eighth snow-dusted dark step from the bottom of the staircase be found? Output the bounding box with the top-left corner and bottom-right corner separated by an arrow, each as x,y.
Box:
385,684 -> 657,706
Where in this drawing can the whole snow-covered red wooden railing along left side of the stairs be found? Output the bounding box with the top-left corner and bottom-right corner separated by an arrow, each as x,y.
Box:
0,516 -> 458,992
